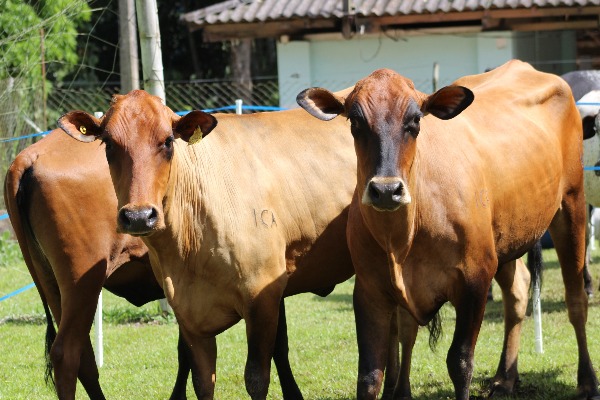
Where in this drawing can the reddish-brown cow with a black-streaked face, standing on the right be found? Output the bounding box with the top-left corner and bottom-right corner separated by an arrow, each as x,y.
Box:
298,61 -> 599,399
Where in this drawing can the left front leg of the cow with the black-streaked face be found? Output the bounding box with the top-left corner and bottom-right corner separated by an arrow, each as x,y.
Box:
353,275 -> 397,400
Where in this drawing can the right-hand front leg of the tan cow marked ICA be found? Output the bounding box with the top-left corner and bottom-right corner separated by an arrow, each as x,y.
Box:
244,279 -> 284,400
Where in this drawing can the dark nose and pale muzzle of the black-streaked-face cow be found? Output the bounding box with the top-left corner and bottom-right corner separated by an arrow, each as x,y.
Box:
362,177 -> 411,211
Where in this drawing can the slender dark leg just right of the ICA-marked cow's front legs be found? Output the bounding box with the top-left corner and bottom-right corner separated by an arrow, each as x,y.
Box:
273,298 -> 303,400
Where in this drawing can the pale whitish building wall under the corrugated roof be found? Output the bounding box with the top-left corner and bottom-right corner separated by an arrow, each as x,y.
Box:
277,32 -> 575,108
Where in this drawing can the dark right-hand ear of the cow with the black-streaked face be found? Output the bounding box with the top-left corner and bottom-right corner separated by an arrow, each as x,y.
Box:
421,86 -> 475,119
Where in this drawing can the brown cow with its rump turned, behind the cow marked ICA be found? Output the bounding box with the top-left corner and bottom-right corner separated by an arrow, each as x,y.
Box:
4,129 -> 299,399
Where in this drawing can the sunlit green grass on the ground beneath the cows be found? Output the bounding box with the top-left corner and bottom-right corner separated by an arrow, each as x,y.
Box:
0,231 -> 600,400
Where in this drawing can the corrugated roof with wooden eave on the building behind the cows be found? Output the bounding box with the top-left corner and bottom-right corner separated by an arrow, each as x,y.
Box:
181,0 -> 600,40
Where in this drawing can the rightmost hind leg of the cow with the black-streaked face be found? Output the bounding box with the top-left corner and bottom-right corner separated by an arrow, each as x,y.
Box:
549,196 -> 600,398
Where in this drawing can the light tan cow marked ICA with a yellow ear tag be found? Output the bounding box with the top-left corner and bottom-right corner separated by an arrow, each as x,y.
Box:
59,91 -> 356,399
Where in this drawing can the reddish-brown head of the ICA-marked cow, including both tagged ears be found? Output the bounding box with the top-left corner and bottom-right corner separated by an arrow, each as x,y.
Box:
58,90 -> 217,236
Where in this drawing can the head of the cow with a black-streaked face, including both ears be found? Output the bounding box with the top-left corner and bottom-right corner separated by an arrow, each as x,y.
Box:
297,69 -> 474,211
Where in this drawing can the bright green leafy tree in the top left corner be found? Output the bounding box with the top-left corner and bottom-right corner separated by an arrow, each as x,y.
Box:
0,0 -> 90,137
